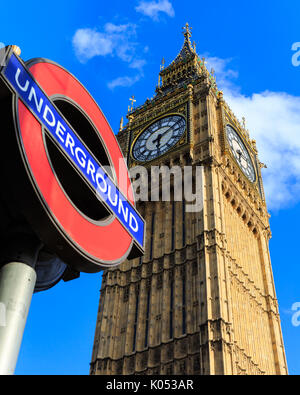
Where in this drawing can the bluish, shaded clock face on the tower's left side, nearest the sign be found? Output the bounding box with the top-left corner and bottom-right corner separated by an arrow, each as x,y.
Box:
132,115 -> 186,162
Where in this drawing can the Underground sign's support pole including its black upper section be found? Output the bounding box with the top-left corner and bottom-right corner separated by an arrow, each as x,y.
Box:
0,227 -> 43,375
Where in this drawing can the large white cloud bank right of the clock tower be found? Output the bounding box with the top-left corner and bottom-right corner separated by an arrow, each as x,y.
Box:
207,57 -> 300,210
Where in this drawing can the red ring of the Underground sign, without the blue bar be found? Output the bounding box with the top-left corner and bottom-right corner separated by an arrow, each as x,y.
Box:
17,60 -> 134,271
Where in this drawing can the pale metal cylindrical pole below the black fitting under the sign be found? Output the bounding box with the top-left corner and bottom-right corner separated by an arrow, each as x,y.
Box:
0,262 -> 36,375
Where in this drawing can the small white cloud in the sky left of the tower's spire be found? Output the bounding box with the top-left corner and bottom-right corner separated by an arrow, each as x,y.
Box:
72,23 -> 136,62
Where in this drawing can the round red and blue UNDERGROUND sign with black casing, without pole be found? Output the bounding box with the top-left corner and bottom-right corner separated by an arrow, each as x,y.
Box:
0,49 -> 145,272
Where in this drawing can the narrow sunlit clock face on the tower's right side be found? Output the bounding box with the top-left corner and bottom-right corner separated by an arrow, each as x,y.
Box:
226,125 -> 256,182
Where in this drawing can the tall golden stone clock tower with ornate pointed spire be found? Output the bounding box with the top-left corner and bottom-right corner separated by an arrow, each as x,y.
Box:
91,25 -> 287,375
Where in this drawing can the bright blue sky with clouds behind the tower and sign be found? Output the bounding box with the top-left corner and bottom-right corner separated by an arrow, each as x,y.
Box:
0,0 -> 300,374
